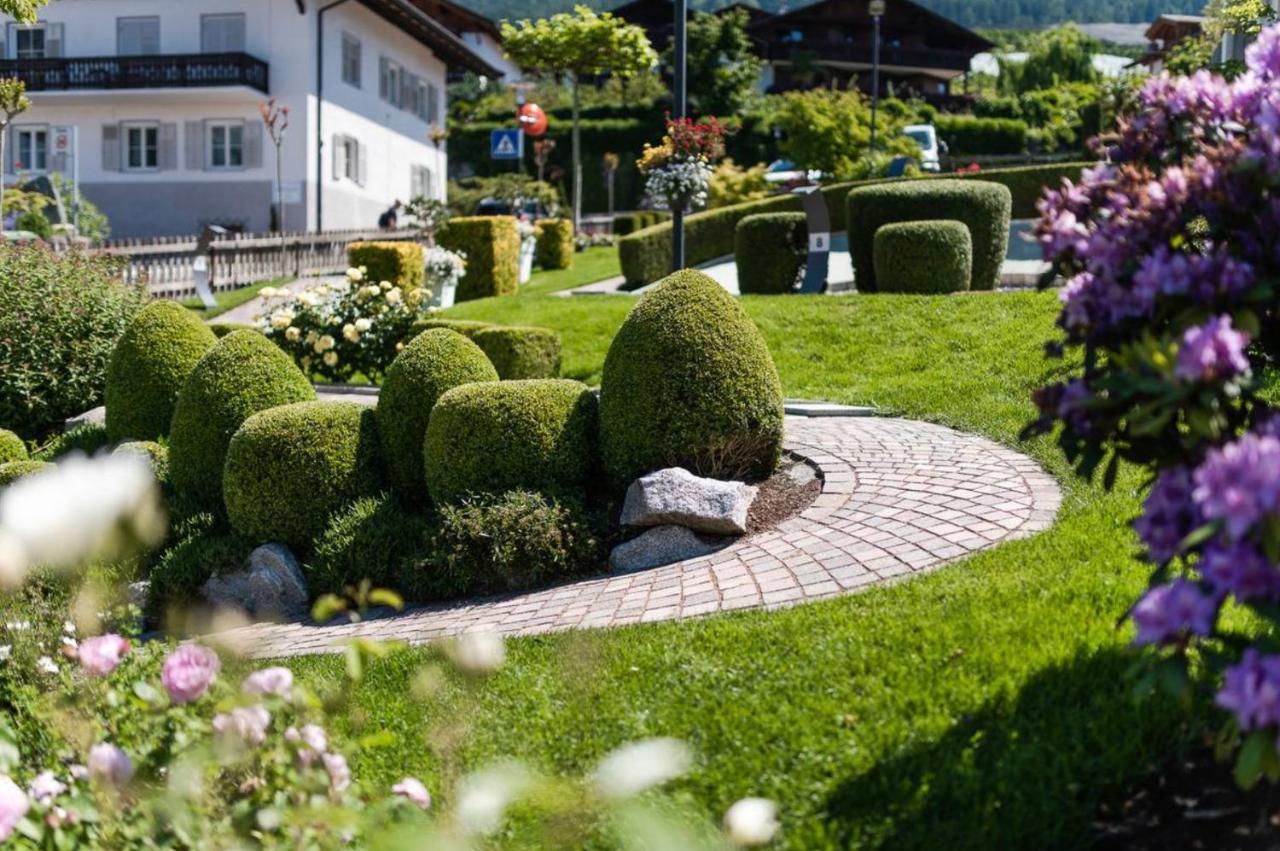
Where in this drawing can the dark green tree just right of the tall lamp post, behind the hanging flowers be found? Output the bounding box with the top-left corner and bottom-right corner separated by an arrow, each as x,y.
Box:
663,9 -> 764,115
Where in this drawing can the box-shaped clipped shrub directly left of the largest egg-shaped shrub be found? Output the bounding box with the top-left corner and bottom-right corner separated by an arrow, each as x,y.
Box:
424,379 -> 596,504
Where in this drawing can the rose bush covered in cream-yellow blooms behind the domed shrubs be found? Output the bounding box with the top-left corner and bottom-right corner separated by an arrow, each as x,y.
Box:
259,267 -> 430,383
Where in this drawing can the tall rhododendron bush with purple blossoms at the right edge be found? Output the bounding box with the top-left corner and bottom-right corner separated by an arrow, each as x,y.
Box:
1029,28 -> 1280,787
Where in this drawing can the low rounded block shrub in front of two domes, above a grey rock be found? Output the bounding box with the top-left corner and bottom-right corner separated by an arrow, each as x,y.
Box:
223,402 -> 381,549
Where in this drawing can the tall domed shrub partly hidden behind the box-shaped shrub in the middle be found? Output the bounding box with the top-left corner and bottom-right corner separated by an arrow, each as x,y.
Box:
378,328 -> 498,503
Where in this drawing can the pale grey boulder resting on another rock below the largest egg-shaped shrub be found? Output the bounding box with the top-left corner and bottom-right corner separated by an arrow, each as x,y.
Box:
622,467 -> 759,535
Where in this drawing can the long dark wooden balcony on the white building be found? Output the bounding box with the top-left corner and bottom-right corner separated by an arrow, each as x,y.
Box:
0,54 -> 270,95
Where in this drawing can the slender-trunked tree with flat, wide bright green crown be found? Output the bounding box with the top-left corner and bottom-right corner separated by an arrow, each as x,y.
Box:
502,6 -> 658,232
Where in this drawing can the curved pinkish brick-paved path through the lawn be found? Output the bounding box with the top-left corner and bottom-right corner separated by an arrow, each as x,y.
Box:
209,417 -> 1061,658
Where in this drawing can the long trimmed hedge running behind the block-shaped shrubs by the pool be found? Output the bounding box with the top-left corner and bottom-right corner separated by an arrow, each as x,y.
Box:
618,163 -> 1092,288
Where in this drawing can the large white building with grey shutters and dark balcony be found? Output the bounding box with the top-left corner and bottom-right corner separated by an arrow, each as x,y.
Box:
0,0 -> 500,237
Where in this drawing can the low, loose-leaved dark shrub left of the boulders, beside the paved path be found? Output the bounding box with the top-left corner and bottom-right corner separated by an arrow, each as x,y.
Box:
434,490 -> 603,594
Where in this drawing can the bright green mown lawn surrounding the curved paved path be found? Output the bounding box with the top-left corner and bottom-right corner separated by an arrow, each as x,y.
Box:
289,293 -> 1198,848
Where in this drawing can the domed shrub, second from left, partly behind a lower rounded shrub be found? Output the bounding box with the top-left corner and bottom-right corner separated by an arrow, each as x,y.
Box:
169,331 -> 316,507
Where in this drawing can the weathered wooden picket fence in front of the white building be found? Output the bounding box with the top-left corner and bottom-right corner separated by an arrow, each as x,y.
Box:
102,230 -> 417,298
